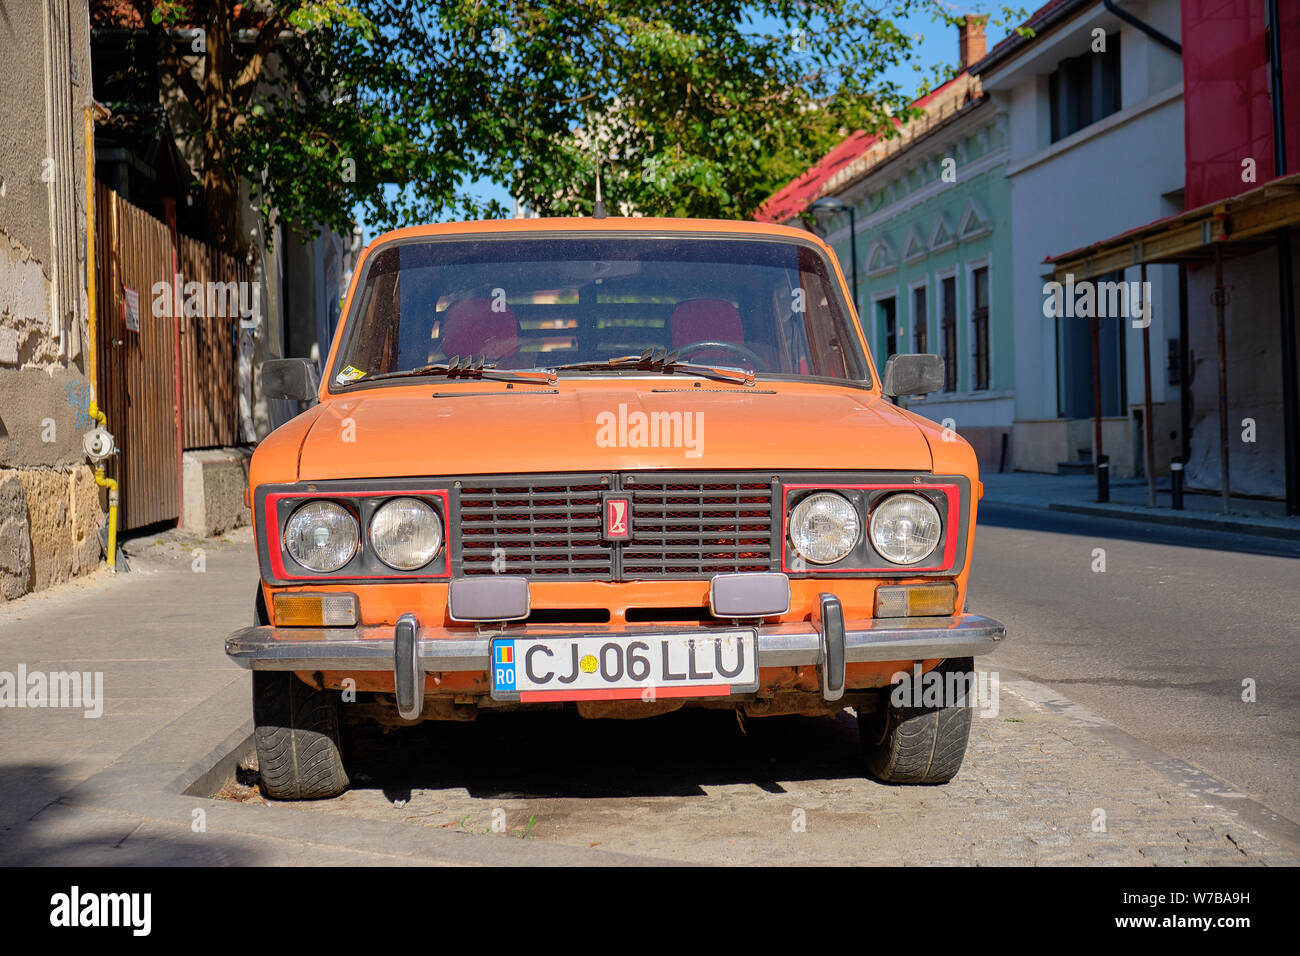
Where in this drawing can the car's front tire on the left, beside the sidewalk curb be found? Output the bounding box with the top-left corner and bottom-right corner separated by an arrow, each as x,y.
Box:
252,671 -> 350,800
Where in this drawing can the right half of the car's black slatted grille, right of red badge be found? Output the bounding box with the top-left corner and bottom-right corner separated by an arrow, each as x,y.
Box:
623,476 -> 772,579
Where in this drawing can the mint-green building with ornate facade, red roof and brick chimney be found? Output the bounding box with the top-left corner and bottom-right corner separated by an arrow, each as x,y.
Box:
759,17 -> 1015,471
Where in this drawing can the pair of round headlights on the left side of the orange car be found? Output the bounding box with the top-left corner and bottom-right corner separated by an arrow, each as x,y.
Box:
285,498 -> 442,574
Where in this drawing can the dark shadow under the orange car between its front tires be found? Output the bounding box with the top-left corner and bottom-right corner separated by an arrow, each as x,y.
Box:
338,710 -> 863,803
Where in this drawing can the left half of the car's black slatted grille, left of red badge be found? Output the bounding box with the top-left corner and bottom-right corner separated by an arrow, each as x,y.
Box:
460,479 -> 614,578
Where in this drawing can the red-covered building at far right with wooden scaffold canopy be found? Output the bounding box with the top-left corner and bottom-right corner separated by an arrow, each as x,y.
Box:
1052,0 -> 1300,514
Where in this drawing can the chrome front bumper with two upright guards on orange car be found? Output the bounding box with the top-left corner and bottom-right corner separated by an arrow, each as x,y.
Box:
226,594 -> 1006,719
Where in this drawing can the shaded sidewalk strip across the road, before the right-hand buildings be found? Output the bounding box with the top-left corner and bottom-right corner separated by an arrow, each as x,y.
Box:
980,471 -> 1300,540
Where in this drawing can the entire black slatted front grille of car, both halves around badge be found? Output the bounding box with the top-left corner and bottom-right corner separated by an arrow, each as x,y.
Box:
459,475 -> 776,580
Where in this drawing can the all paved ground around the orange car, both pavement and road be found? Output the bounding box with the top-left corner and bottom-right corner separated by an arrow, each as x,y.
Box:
0,505 -> 1300,865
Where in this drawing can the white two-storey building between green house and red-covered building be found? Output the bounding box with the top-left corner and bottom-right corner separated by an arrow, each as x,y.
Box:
971,0 -> 1184,476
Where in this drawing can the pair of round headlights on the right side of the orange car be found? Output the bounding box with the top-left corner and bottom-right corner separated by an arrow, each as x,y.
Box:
789,492 -> 943,564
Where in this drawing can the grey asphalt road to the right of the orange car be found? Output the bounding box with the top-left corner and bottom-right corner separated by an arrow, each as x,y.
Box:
969,505 -> 1300,821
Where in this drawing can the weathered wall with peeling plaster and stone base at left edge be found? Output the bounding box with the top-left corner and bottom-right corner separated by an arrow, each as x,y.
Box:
0,0 -> 103,602
